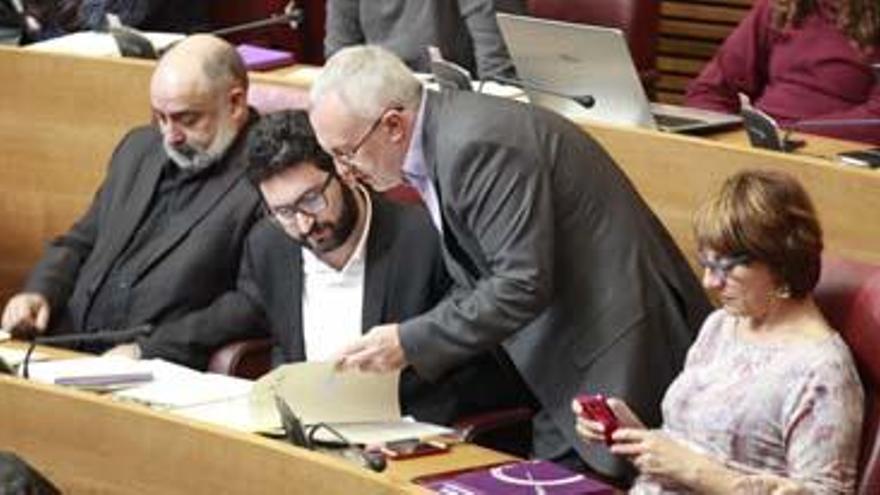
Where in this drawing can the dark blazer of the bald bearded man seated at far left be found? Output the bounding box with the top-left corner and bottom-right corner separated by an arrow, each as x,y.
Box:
25,117 -> 260,368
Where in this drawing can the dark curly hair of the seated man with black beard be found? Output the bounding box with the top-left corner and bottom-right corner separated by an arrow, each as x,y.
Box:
247,110 -> 336,185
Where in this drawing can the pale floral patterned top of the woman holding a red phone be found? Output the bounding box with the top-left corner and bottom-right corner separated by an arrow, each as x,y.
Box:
630,310 -> 864,494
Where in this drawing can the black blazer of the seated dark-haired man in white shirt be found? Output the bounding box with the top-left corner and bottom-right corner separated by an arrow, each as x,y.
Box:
239,195 -> 524,424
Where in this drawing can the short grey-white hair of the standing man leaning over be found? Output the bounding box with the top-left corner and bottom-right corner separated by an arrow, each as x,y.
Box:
309,45 -> 422,120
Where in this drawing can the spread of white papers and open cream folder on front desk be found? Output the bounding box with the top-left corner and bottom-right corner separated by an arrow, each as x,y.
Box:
24,356 -> 452,444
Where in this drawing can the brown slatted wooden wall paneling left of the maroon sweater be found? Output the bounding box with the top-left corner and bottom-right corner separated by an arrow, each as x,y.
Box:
656,0 -> 752,103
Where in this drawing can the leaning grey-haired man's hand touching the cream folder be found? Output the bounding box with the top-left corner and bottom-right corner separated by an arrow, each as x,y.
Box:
334,323 -> 406,373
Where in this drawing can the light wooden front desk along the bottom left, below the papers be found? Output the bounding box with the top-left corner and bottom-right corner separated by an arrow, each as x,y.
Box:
0,342 -> 515,494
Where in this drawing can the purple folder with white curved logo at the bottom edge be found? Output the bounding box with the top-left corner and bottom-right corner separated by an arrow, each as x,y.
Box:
425,461 -> 614,495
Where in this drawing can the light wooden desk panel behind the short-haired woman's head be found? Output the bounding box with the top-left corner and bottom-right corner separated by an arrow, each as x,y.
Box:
583,123 -> 880,263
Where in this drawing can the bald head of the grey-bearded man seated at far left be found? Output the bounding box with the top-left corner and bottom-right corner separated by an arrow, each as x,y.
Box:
150,34 -> 248,168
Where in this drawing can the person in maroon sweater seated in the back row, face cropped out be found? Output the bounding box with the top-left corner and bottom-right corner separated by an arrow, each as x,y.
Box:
686,0 -> 880,145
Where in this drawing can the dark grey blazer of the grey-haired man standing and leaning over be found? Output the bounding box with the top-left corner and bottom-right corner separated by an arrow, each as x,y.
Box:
401,91 -> 709,472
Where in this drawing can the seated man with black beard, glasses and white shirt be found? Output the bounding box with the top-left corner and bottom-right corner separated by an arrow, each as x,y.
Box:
230,111 -> 528,424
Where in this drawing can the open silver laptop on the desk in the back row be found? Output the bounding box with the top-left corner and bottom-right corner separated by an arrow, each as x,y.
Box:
498,14 -> 742,133
